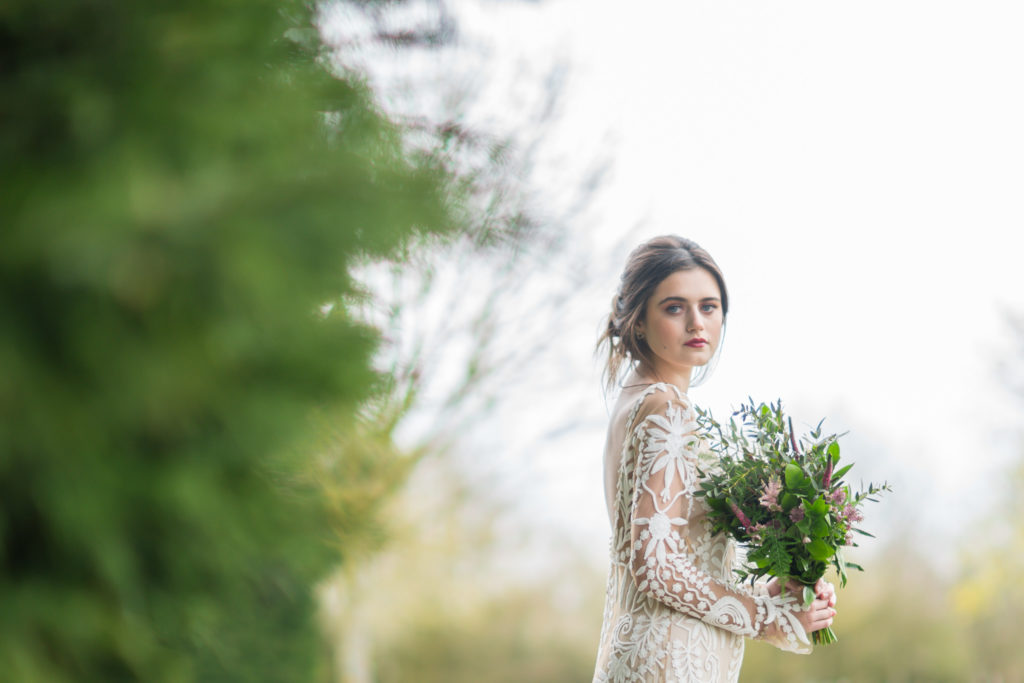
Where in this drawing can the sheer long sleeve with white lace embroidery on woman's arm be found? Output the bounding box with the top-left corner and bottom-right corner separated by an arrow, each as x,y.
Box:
630,391 -> 810,652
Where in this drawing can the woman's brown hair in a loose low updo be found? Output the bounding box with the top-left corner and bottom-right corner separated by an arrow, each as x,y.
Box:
597,234 -> 729,389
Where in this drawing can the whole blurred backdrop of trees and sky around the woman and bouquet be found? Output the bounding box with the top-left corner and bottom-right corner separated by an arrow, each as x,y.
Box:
0,0 -> 1024,683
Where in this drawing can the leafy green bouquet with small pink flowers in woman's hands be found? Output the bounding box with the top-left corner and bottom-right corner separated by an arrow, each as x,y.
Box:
694,399 -> 891,644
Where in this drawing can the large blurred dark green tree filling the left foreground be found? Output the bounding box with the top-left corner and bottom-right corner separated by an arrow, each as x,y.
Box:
0,0 -> 460,682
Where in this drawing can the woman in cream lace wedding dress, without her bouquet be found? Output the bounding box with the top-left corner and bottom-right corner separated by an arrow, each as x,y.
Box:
594,236 -> 836,682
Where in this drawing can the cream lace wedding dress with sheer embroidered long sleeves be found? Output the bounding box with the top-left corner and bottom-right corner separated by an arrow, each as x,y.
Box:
594,384 -> 811,683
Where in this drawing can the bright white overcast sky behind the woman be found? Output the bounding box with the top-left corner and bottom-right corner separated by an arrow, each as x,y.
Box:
327,0 -> 1024,577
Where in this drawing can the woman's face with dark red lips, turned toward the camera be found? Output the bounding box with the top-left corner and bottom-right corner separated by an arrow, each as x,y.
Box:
640,267 -> 723,381
